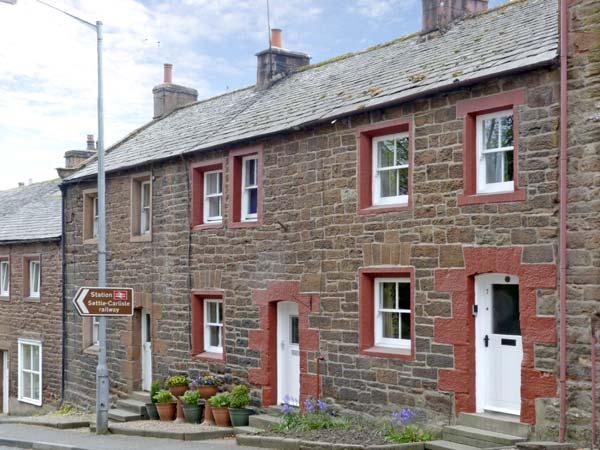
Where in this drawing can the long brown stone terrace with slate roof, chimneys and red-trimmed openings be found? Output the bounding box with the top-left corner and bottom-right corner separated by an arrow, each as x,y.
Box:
58,0 -> 600,440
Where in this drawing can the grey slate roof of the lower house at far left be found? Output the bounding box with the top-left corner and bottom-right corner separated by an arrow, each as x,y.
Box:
0,179 -> 62,244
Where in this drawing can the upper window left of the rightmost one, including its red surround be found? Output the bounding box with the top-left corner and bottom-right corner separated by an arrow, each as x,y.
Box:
356,119 -> 413,214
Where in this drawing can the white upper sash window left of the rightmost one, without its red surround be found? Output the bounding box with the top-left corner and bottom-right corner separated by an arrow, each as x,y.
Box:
372,133 -> 409,206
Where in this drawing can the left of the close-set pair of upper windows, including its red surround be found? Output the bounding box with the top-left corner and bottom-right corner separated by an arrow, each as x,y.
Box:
190,159 -> 224,230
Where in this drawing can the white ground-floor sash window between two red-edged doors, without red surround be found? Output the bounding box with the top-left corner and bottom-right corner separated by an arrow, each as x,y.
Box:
374,278 -> 412,349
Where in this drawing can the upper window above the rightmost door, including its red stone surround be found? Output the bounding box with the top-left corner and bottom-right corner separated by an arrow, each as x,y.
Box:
456,89 -> 526,205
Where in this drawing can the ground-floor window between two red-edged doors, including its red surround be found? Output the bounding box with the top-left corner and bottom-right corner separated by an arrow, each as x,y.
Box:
359,267 -> 415,359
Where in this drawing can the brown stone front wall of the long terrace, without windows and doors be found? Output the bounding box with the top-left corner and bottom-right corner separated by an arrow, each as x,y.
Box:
65,68 -> 559,432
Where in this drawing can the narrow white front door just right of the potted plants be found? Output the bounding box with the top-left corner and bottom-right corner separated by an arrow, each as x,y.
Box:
277,302 -> 300,405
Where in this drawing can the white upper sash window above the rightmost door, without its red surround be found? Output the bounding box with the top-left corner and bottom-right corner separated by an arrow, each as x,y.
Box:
476,110 -> 515,194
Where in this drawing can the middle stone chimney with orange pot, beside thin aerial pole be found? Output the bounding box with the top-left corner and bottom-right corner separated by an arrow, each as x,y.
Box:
256,28 -> 310,89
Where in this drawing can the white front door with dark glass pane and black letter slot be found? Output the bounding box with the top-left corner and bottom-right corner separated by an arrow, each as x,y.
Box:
475,273 -> 523,415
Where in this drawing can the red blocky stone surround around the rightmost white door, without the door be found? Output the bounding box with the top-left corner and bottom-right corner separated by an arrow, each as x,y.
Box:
434,247 -> 556,424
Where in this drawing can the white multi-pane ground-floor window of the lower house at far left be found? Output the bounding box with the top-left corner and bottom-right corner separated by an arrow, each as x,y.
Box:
18,339 -> 42,406
